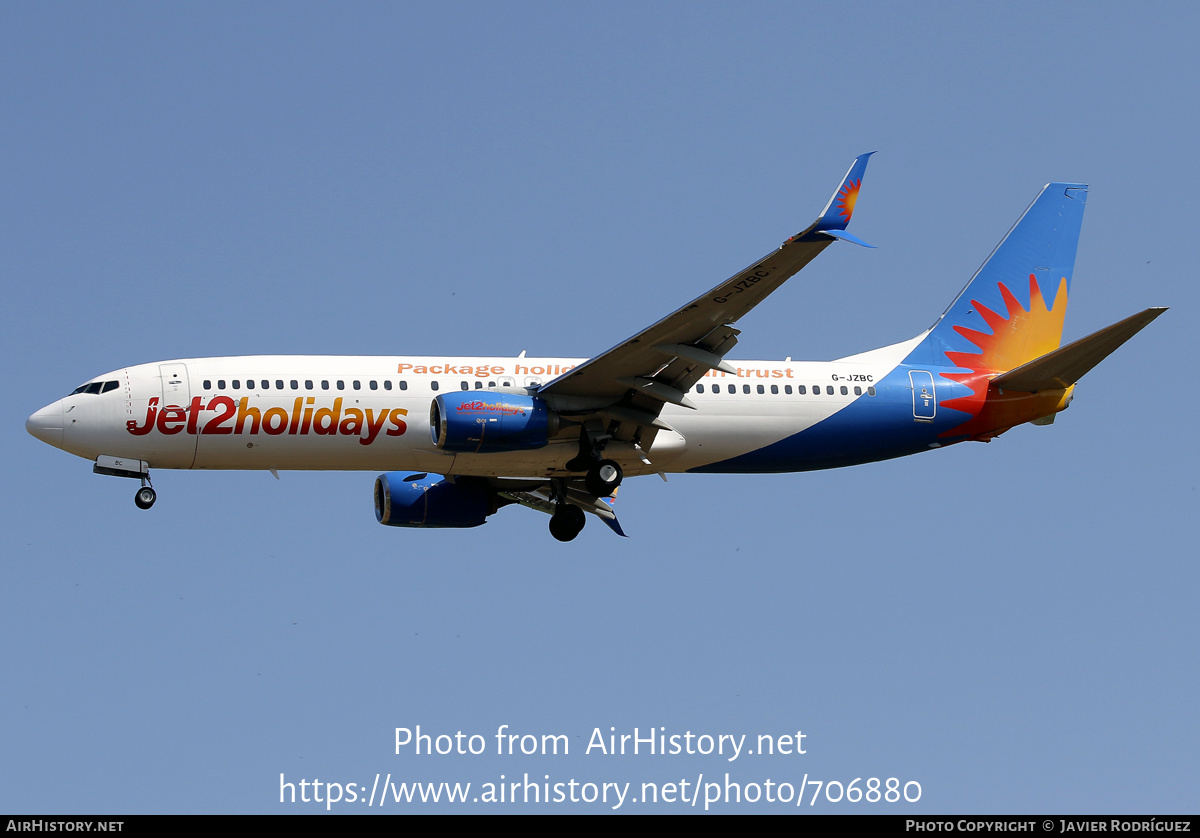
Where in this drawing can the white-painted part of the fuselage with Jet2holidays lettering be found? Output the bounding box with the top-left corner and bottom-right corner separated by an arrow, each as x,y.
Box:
30,345 -> 906,477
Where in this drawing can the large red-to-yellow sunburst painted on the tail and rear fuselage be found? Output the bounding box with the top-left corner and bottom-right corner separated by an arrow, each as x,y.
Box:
942,274 -> 1067,438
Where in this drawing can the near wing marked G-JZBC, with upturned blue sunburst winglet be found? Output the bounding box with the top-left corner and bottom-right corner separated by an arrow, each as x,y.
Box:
539,151 -> 874,425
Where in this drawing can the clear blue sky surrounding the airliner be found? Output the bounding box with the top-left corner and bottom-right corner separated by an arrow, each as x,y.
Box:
0,2 -> 1200,813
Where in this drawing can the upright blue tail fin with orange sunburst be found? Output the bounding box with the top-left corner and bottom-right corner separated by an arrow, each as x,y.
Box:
908,184 -> 1087,372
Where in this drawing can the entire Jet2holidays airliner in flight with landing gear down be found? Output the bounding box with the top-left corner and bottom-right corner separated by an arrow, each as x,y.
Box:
25,154 -> 1165,541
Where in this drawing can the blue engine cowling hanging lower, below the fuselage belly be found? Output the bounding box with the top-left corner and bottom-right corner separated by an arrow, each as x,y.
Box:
374,472 -> 496,527
